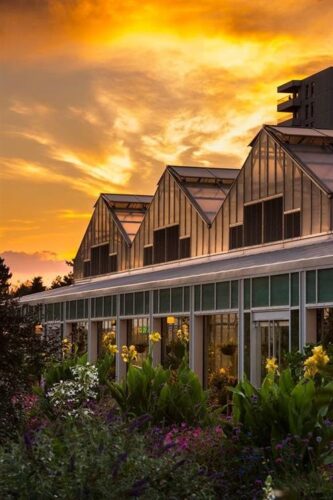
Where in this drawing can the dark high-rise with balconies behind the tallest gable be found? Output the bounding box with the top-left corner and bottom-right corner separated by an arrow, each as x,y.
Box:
277,66 -> 333,129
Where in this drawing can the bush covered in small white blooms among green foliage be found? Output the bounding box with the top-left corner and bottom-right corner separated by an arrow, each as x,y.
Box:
47,363 -> 99,417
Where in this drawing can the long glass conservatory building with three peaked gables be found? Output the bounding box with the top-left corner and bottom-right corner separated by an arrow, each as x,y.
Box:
21,125 -> 333,387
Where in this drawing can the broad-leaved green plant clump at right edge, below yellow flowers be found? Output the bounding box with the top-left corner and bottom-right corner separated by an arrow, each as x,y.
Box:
230,368 -> 333,461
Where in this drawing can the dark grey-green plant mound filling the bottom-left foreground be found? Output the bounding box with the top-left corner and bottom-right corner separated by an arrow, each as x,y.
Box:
0,417 -> 215,500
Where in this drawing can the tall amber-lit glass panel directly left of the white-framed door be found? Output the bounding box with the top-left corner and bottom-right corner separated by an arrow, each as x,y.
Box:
204,314 -> 238,390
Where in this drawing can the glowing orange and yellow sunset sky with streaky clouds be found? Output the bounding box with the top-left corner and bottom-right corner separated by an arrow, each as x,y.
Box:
0,0 -> 333,282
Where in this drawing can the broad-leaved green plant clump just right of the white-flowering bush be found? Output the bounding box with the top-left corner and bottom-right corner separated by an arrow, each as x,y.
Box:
109,355 -> 207,423
